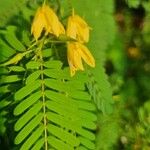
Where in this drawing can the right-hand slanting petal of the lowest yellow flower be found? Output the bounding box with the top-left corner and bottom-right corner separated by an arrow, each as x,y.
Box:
78,43 -> 95,67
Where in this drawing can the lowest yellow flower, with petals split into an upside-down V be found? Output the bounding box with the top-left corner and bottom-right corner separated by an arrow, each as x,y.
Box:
67,42 -> 95,76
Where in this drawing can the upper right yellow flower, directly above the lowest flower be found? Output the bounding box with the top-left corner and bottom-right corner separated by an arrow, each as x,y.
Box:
67,12 -> 90,43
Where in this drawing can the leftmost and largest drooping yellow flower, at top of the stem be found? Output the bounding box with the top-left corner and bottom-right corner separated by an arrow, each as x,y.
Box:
31,4 -> 65,40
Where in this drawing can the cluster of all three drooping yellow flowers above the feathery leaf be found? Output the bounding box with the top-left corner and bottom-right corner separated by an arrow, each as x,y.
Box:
31,4 -> 95,76
